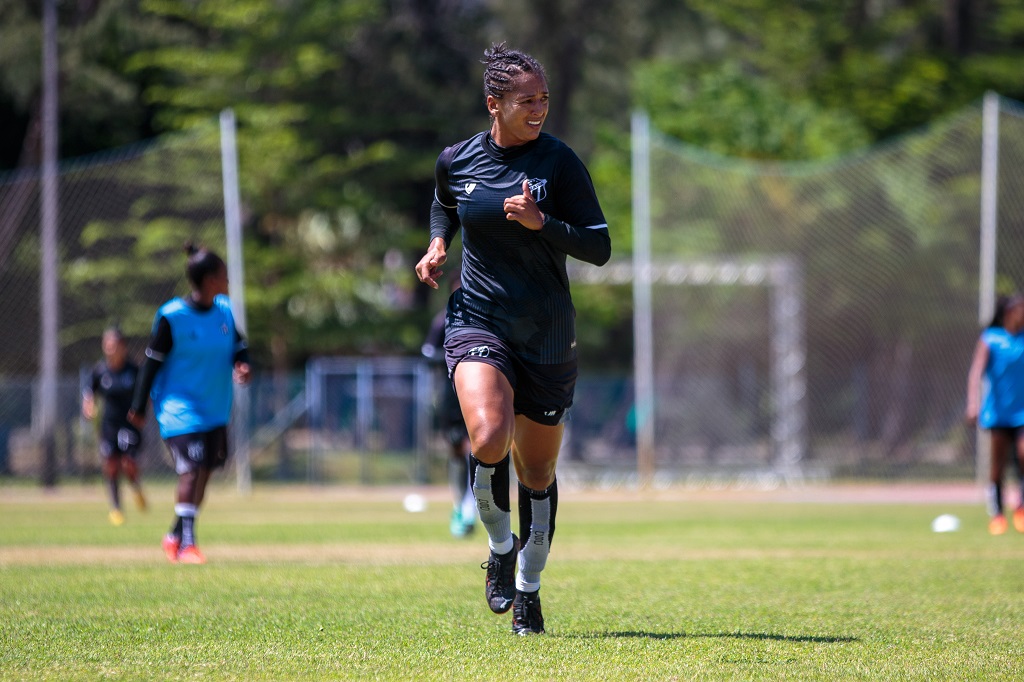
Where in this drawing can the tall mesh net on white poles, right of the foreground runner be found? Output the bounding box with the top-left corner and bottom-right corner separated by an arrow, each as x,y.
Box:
626,99 -> 1024,478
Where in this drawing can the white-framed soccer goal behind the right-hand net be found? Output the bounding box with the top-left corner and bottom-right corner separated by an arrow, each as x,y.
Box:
569,257 -> 806,484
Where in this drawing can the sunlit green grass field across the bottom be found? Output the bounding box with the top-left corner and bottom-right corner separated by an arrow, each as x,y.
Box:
0,483 -> 1024,681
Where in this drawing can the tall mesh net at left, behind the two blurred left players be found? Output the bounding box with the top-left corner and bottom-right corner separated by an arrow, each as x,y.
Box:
0,122 -> 224,475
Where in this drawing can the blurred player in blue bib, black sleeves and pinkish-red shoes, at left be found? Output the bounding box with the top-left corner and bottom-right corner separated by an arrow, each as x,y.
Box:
128,243 -> 250,563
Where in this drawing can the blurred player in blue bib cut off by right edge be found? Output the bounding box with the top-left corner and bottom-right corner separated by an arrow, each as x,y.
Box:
966,295 -> 1024,536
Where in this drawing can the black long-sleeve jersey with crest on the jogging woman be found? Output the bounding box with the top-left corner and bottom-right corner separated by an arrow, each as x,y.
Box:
430,132 -> 611,365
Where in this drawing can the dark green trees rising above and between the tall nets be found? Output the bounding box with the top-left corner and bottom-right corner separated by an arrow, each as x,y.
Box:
0,0 -> 1024,376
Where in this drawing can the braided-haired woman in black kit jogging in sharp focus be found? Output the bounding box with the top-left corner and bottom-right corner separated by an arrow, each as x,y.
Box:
416,43 -> 611,635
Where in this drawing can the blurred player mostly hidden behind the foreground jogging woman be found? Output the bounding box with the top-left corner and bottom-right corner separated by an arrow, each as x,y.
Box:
422,273 -> 476,538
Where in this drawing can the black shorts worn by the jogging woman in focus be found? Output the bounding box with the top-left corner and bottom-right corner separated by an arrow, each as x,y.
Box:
444,328 -> 577,426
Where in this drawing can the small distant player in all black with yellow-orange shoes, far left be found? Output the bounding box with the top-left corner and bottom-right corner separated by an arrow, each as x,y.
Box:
82,327 -> 146,525
